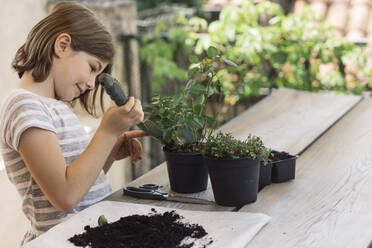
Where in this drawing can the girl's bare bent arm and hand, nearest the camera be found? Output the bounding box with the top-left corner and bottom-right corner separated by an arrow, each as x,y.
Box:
18,98 -> 143,212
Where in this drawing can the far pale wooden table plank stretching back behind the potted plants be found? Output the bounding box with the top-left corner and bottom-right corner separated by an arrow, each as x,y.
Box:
219,88 -> 361,155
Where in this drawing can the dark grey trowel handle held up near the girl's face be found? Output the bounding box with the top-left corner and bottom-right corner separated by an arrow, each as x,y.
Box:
98,73 -> 129,106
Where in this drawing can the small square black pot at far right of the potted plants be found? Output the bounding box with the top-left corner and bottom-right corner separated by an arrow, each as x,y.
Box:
271,151 -> 298,183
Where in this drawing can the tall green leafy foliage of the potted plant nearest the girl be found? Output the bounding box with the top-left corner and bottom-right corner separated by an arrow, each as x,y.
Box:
144,47 -> 235,152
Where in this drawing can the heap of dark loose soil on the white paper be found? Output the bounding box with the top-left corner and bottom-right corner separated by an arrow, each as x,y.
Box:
69,209 -> 213,248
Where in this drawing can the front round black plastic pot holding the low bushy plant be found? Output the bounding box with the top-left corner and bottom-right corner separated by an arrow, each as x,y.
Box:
204,157 -> 260,206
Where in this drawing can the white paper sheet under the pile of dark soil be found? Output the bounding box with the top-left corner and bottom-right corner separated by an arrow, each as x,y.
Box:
23,201 -> 270,248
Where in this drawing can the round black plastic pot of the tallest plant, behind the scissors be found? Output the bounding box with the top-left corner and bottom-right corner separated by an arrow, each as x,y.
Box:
164,151 -> 208,193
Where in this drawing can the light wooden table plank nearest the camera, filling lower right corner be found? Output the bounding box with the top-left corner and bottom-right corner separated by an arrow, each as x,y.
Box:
240,98 -> 372,248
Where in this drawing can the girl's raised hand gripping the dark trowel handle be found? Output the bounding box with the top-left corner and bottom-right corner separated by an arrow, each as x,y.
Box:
99,96 -> 144,136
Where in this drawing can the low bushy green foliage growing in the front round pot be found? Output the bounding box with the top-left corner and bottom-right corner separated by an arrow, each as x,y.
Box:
202,132 -> 271,164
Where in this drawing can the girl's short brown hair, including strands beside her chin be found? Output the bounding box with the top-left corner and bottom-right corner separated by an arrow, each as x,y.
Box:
12,2 -> 115,116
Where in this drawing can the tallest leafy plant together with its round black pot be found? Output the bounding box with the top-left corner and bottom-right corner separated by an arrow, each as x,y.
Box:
144,47 -> 237,193
